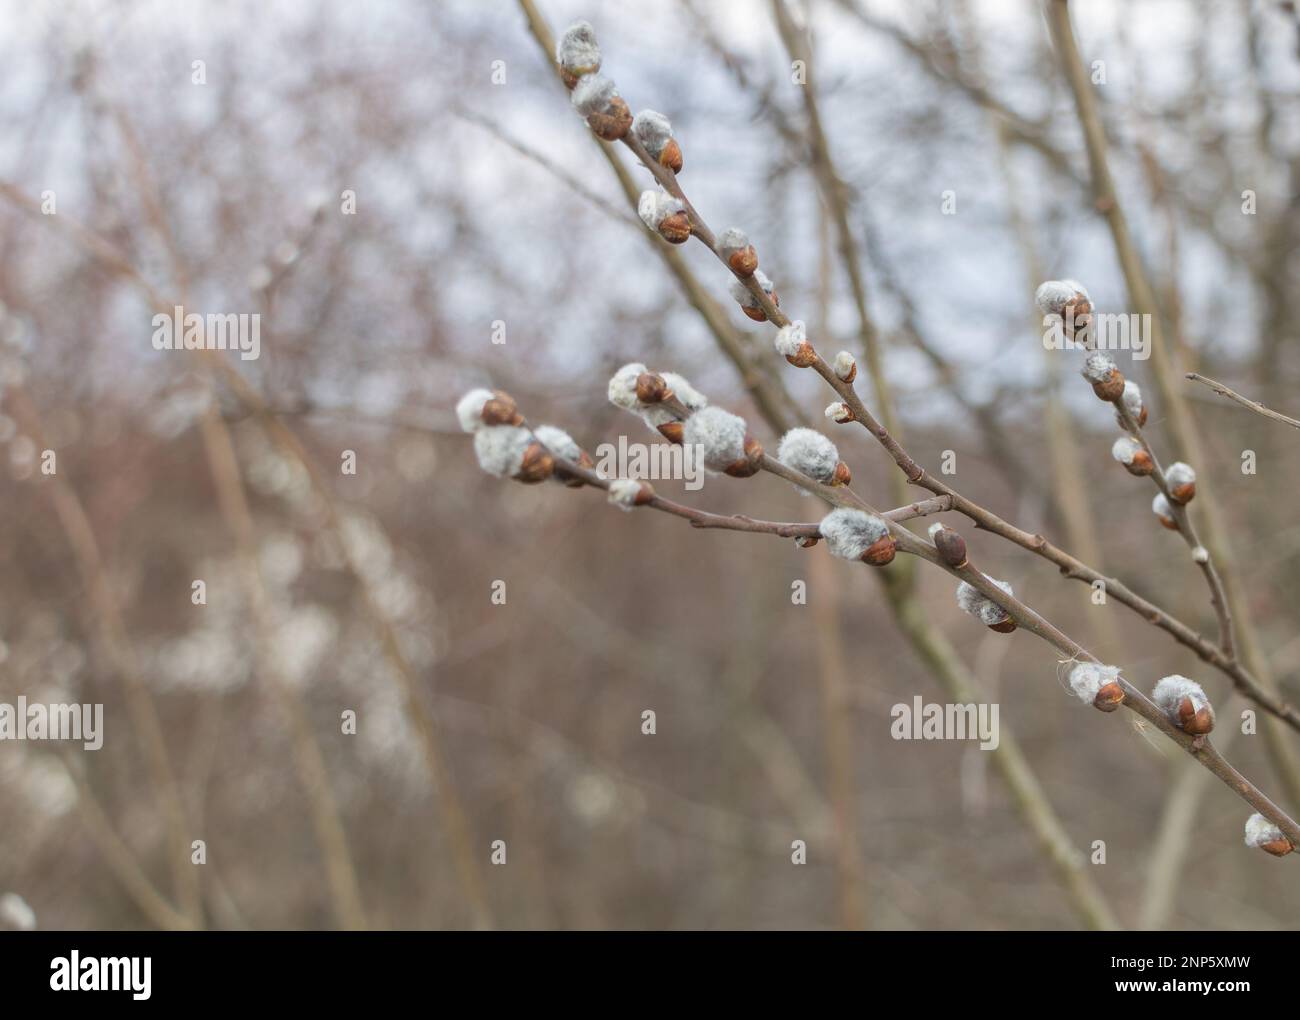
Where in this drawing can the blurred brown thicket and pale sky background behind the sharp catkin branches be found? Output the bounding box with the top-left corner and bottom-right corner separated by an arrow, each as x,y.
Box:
0,0 -> 1300,929
